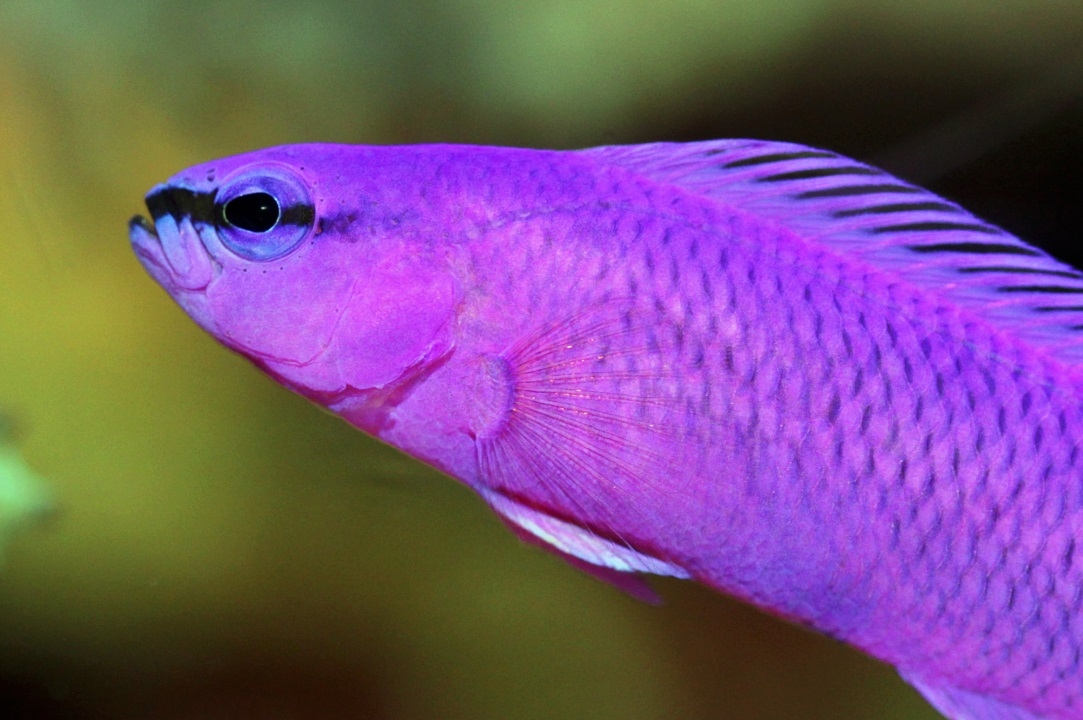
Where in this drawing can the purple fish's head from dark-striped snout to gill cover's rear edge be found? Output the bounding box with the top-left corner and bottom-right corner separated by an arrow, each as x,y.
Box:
129,145 -> 457,405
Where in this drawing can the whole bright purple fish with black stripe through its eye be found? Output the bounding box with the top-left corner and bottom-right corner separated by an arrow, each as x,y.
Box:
130,140 -> 1083,720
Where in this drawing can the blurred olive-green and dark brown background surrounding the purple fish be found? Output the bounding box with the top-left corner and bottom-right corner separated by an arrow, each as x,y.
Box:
0,0 -> 1083,720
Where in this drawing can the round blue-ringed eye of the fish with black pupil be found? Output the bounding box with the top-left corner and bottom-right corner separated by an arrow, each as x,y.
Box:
214,163 -> 315,262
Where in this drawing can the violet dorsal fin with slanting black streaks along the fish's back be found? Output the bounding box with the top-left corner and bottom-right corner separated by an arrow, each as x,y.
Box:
582,140 -> 1083,364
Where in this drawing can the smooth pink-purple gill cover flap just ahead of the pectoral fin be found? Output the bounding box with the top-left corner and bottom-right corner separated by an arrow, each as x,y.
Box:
320,260 -> 458,390
